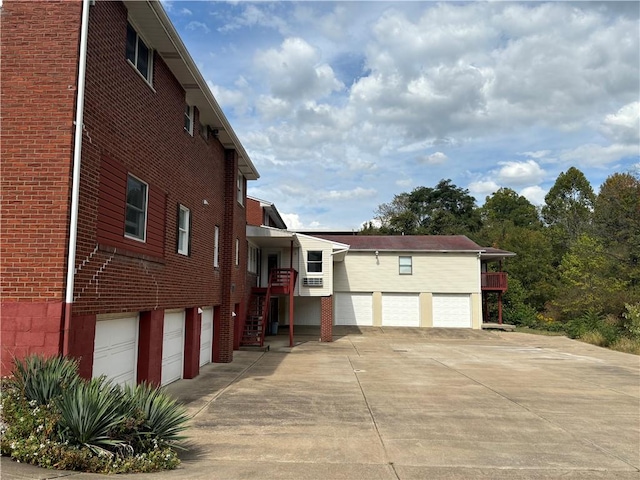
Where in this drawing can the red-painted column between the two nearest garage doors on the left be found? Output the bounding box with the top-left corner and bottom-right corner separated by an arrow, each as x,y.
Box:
137,310 -> 164,386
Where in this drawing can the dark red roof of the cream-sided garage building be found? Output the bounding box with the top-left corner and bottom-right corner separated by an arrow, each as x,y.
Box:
307,234 -> 485,252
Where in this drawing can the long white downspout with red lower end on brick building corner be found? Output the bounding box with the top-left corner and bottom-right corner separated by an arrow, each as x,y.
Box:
62,0 -> 91,355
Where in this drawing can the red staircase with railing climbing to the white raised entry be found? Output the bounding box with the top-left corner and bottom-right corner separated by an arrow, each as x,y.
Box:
240,268 -> 298,347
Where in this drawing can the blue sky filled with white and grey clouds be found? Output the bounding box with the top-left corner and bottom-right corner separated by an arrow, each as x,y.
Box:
163,0 -> 640,230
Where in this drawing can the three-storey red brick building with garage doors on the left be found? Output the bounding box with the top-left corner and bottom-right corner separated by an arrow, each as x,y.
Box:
0,0 -> 258,384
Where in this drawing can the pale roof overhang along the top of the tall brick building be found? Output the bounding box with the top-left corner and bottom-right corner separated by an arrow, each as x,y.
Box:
124,0 -> 260,180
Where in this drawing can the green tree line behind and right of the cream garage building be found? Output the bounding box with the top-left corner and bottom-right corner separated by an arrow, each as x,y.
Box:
360,167 -> 640,326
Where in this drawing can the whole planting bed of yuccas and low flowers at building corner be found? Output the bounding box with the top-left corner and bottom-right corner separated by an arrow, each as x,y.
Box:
0,357 -> 188,473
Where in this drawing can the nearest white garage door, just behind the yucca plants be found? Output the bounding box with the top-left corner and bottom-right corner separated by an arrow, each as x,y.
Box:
92,314 -> 138,385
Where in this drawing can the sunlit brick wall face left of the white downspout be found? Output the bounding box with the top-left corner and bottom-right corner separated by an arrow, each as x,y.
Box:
0,1 -> 81,375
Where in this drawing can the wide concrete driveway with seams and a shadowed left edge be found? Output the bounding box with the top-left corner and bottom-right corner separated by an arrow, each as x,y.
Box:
2,328 -> 640,480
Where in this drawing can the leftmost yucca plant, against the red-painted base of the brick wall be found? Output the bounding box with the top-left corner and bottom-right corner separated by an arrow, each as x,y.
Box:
13,355 -> 79,405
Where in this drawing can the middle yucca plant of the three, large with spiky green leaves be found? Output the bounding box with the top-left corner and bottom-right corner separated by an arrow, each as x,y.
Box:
55,377 -> 130,456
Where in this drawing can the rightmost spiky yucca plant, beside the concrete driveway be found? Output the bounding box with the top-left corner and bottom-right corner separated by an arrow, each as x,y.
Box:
124,382 -> 189,448
